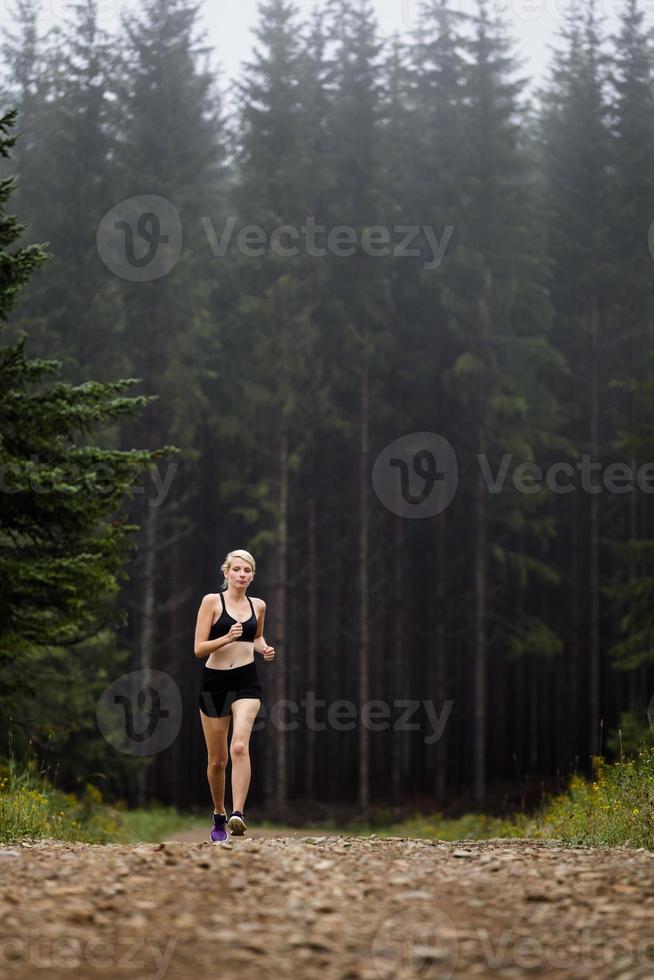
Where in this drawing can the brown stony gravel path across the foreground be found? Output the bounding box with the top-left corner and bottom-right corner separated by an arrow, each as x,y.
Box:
0,827 -> 654,980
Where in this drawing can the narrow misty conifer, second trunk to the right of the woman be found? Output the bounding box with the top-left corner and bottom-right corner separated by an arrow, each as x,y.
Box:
288,9 -> 338,799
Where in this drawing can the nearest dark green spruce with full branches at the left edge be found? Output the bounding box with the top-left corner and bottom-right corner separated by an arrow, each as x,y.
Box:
0,110 -> 172,771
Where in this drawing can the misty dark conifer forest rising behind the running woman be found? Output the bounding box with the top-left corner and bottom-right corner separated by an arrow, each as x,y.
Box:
0,0 -> 654,816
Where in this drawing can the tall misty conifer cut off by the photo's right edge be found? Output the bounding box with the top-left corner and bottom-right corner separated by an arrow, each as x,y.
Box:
606,0 -> 654,704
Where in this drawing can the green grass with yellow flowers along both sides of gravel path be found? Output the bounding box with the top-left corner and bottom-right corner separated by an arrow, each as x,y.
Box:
0,748 -> 654,850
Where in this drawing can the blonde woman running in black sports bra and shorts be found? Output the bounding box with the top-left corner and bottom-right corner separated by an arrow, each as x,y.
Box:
195,550 -> 275,844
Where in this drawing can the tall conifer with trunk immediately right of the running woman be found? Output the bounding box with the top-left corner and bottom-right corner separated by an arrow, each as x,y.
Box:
228,0 -> 324,814
